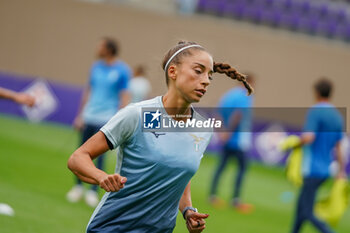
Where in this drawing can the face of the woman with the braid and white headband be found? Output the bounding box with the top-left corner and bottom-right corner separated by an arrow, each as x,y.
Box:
175,50 -> 213,103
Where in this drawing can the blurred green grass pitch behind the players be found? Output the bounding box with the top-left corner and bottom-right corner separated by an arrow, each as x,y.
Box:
0,115 -> 350,233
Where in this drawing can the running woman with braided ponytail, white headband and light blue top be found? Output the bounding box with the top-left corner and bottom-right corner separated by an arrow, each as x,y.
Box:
68,42 -> 252,233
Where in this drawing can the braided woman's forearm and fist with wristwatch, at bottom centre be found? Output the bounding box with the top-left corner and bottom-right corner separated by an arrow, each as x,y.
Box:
179,181 -> 209,233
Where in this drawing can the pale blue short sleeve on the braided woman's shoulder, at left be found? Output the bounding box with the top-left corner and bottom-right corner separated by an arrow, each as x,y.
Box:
101,105 -> 140,148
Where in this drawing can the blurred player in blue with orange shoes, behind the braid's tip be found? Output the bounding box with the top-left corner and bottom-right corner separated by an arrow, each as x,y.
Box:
209,75 -> 254,213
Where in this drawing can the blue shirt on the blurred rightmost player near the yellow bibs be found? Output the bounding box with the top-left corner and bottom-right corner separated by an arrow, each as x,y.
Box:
303,102 -> 344,178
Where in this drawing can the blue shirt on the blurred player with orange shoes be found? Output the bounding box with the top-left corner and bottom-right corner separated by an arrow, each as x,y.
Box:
218,87 -> 253,151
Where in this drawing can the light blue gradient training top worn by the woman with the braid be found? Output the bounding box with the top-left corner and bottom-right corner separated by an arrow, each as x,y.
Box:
87,96 -> 212,233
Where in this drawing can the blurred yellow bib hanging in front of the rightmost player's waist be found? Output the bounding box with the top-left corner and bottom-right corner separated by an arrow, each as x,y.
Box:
280,135 -> 303,187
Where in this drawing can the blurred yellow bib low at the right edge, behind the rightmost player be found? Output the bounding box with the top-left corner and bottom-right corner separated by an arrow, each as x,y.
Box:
315,178 -> 349,226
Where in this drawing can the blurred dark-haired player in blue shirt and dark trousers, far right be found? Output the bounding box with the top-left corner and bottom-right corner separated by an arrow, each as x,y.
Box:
292,79 -> 346,233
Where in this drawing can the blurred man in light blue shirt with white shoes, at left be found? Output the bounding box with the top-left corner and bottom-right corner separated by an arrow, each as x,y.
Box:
67,38 -> 131,207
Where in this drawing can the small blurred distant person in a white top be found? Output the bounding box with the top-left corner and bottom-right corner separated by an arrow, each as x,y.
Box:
129,65 -> 151,103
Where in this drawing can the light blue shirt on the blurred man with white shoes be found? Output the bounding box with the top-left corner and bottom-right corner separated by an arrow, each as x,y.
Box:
82,60 -> 131,126
